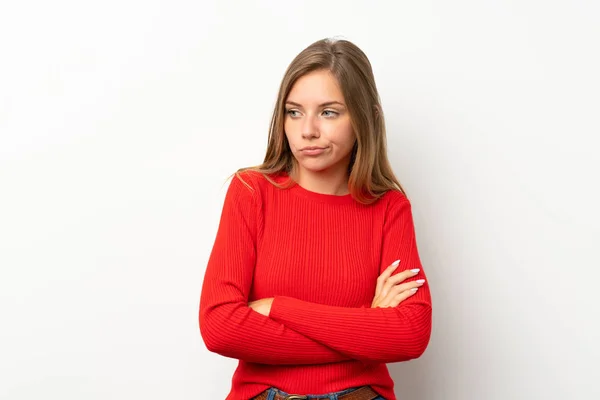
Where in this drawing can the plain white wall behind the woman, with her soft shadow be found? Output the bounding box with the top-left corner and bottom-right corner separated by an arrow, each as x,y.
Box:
0,0 -> 600,400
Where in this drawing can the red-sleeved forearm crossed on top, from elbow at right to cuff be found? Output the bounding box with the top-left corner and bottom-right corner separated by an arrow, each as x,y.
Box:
270,293 -> 431,363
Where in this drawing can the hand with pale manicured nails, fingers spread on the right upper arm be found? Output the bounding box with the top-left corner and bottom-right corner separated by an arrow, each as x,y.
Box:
371,260 -> 425,308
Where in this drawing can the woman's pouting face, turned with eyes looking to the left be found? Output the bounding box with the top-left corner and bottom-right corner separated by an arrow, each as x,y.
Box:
284,70 -> 356,176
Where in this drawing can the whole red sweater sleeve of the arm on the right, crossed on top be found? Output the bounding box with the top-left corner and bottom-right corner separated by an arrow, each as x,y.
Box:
269,192 -> 432,363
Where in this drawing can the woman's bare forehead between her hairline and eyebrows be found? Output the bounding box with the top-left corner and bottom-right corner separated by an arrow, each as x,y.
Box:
286,70 -> 344,104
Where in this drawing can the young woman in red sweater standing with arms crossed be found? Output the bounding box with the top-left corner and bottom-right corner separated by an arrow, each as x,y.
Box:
199,39 -> 432,400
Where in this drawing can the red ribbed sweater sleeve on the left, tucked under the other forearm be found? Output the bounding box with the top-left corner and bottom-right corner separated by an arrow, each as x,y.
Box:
199,176 -> 350,364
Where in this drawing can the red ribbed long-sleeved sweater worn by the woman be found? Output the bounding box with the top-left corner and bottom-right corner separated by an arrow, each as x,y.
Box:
199,172 -> 431,400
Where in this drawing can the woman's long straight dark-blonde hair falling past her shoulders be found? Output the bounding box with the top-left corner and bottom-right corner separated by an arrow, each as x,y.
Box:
235,38 -> 406,204
